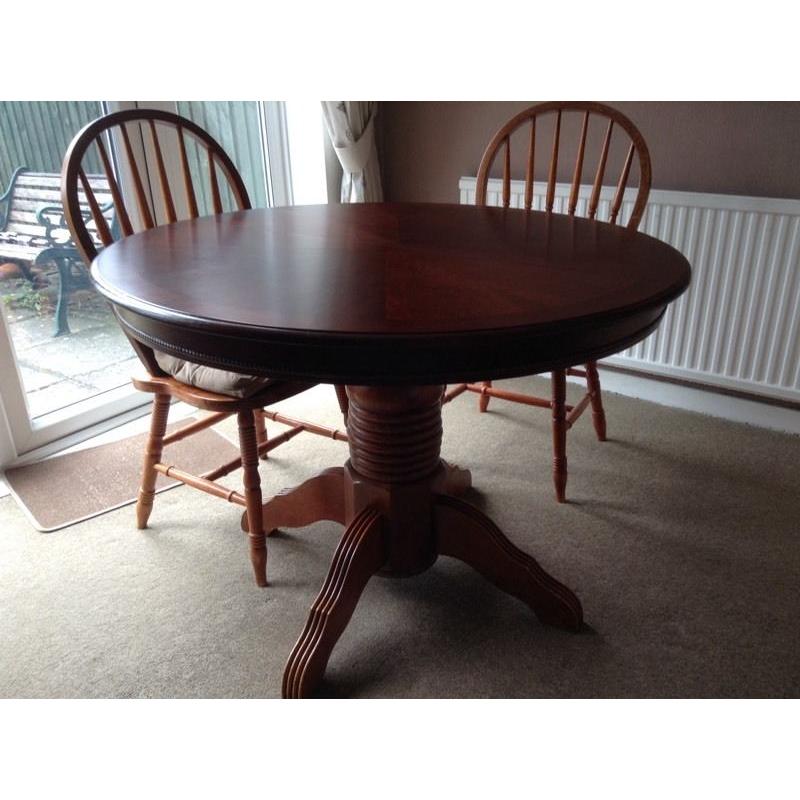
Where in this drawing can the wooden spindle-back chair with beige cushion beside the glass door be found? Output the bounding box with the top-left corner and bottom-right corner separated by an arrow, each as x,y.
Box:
61,109 -> 347,586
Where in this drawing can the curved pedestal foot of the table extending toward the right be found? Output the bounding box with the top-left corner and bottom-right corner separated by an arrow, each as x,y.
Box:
434,495 -> 583,630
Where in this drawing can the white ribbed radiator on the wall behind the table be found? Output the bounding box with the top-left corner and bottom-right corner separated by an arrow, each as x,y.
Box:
458,178 -> 800,402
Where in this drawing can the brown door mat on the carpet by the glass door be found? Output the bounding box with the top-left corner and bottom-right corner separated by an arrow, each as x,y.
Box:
5,418 -> 239,533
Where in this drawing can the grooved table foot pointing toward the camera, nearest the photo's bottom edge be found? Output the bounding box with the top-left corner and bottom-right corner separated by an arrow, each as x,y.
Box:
283,508 -> 387,698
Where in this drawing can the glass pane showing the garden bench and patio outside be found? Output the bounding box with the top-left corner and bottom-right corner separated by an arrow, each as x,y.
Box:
0,102 -> 137,418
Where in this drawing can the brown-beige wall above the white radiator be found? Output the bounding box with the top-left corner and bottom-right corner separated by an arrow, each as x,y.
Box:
378,101 -> 800,203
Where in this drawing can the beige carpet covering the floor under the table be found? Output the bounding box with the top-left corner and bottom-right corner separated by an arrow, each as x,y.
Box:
0,381 -> 800,697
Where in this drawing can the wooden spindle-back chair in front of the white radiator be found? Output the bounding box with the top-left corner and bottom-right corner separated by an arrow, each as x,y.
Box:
445,102 -> 651,503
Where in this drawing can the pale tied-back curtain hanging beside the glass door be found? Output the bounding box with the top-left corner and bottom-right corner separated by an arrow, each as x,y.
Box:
322,100 -> 383,203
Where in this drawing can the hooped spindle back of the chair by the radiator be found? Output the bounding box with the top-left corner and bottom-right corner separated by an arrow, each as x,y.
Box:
475,101 -> 652,230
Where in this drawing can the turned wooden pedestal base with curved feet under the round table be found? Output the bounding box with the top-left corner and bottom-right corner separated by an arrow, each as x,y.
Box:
253,386 -> 583,697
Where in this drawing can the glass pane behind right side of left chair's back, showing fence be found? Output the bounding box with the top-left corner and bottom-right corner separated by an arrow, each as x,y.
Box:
177,100 -> 267,209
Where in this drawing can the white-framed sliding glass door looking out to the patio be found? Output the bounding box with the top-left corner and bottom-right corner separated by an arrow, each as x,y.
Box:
0,101 -> 326,464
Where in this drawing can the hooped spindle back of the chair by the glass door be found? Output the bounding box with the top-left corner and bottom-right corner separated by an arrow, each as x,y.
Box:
61,108 -> 251,266
